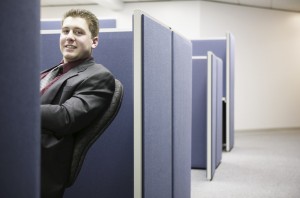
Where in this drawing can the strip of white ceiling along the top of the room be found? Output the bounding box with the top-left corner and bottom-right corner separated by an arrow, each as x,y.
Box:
41,0 -> 300,12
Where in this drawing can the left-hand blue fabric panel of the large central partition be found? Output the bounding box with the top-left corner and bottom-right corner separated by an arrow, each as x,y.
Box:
142,15 -> 172,198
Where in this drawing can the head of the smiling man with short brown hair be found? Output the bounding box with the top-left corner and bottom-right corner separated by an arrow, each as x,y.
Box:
60,9 -> 99,62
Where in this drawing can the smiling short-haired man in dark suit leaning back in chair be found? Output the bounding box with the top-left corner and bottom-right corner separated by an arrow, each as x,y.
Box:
40,9 -> 115,198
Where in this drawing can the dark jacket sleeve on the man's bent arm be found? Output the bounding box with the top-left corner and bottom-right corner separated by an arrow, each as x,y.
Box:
41,68 -> 115,137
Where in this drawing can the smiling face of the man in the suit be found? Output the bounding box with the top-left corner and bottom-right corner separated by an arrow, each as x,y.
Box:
60,17 -> 98,63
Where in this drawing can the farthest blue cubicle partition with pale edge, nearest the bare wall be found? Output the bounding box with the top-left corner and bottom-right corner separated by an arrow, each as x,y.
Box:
192,33 -> 235,151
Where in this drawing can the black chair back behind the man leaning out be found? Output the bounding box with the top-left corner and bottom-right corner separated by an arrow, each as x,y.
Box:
67,79 -> 124,187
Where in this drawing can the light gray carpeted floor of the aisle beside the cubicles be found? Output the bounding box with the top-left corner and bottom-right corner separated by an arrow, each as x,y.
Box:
191,129 -> 300,198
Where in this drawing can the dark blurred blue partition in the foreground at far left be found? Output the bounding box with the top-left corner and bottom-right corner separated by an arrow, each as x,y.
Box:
0,0 -> 41,198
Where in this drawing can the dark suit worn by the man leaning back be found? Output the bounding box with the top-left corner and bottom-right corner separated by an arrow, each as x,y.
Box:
41,59 -> 115,198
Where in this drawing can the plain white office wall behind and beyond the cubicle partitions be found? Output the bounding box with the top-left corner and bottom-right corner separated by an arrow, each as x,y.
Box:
41,1 -> 300,130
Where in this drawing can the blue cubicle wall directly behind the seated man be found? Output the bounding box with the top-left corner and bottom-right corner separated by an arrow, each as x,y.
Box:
41,32 -> 133,198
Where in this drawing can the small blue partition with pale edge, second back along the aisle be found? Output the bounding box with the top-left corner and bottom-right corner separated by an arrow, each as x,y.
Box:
192,52 -> 223,180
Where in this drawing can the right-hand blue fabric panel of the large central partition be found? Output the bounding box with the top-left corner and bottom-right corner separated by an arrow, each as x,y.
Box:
172,32 -> 192,198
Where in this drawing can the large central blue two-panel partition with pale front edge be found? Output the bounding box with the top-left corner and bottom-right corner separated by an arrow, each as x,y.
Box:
134,11 -> 191,198
